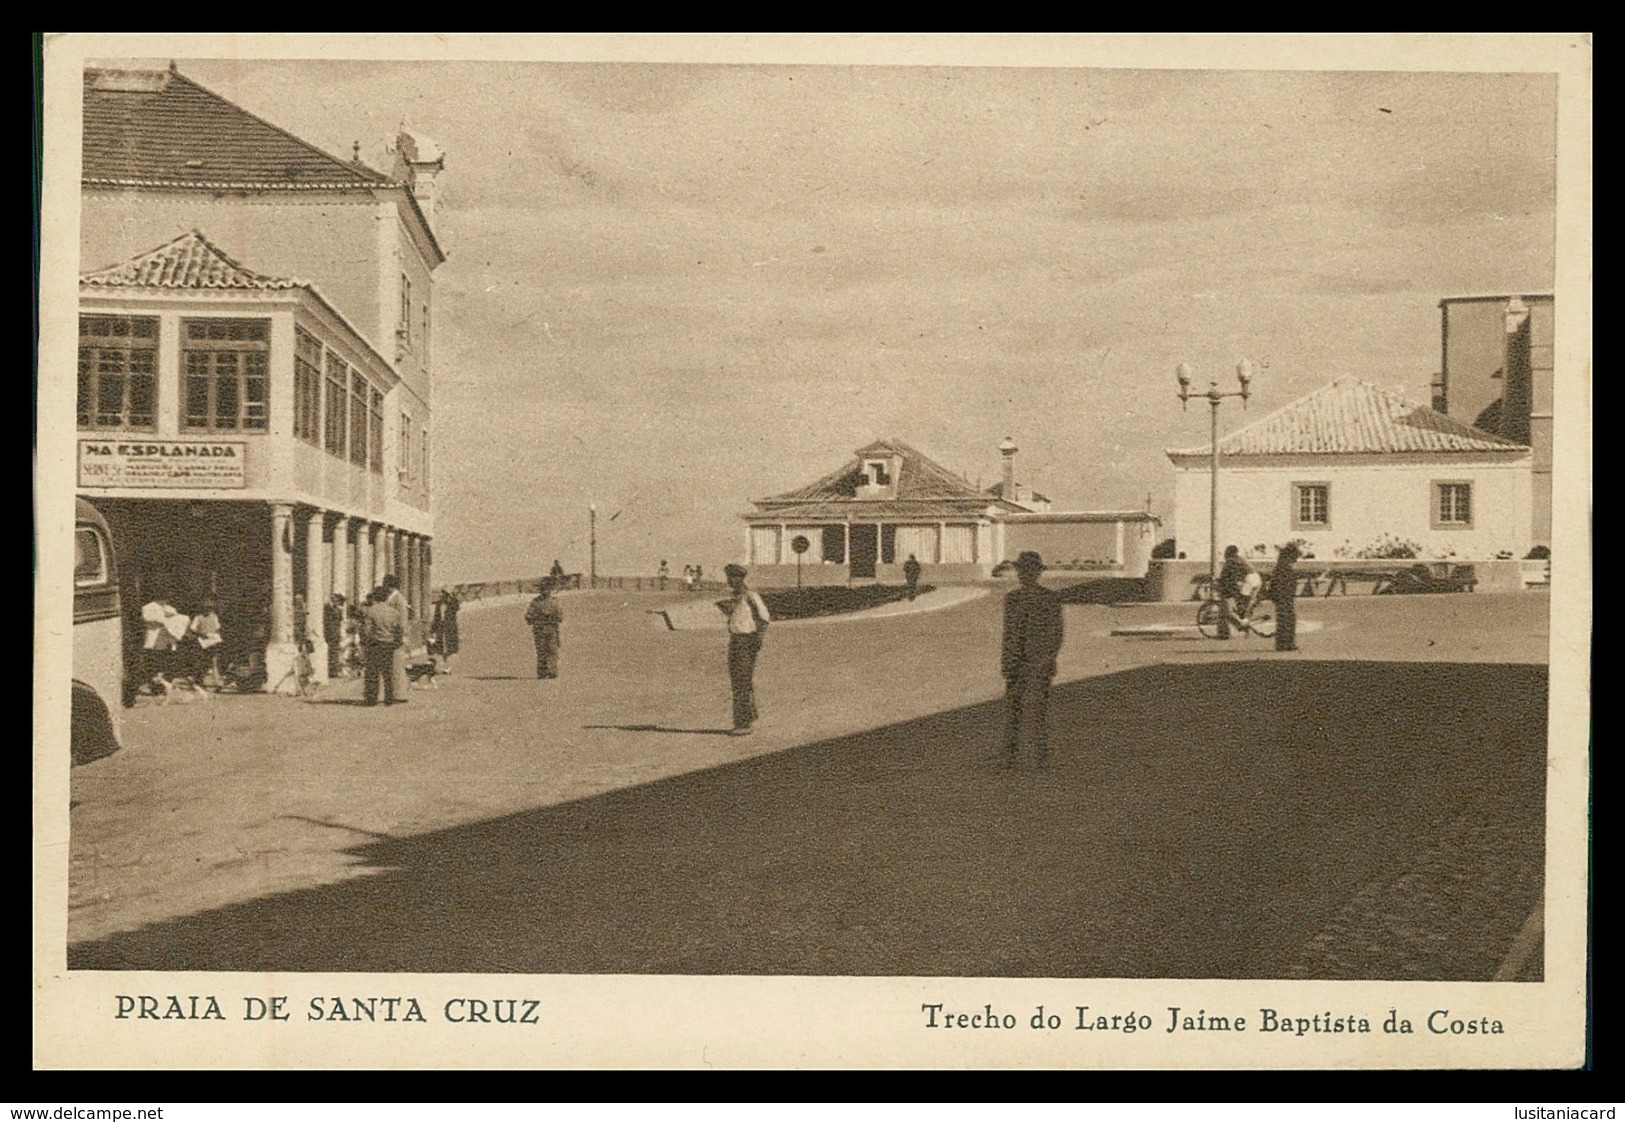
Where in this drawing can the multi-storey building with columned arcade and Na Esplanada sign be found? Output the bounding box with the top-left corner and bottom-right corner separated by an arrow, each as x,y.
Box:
76,65 -> 445,685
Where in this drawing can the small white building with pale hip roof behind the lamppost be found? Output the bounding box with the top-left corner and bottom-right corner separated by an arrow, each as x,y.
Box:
1168,377 -> 1531,561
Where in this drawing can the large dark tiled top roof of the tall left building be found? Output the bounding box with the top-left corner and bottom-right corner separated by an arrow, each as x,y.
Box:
81,70 -> 392,190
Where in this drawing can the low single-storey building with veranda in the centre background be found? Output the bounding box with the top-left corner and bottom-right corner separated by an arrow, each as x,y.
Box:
743,439 -> 1157,585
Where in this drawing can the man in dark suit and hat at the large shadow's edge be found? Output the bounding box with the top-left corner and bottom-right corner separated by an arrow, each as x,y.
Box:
1001,550 -> 1063,768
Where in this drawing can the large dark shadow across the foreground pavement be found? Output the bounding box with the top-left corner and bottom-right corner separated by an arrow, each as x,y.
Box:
68,660 -> 1547,979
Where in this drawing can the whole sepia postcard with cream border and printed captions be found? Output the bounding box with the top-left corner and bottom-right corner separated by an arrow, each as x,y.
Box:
34,34 -> 1591,1068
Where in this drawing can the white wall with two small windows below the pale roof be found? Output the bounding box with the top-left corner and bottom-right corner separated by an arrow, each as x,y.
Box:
1173,455 -> 1531,561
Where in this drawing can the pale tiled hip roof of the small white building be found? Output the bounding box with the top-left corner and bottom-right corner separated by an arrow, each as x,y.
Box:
1168,377 -> 1528,457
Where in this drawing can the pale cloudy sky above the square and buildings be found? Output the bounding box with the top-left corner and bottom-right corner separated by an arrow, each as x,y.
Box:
158,46 -> 1557,582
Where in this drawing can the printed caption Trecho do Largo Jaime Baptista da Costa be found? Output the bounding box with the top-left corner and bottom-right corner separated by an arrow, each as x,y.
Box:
920,1003 -> 1506,1036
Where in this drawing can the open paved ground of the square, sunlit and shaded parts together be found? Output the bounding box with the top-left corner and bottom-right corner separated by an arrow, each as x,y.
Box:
63,594 -> 1545,979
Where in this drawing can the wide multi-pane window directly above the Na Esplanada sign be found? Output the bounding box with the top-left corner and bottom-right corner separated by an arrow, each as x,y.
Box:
180,319 -> 271,433
